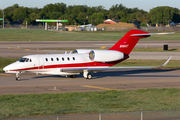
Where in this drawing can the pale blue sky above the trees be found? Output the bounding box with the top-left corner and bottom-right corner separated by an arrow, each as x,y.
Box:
0,0 -> 180,12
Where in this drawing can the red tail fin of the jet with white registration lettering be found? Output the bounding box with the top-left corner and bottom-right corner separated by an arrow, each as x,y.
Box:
109,30 -> 151,54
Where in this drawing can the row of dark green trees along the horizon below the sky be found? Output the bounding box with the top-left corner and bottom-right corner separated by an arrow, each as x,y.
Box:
0,3 -> 180,25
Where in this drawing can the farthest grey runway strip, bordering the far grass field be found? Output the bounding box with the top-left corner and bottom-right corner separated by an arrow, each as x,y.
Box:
0,40 -> 180,49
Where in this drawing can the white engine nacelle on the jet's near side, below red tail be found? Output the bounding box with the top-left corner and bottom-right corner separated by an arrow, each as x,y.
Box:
89,50 -> 124,62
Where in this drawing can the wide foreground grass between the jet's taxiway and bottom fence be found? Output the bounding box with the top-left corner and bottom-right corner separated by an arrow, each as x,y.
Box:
0,88 -> 180,118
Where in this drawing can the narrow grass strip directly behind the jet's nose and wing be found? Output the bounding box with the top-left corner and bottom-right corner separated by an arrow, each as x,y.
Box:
0,58 -> 180,72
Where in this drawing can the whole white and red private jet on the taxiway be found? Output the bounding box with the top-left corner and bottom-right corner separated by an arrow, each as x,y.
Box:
3,30 -> 171,80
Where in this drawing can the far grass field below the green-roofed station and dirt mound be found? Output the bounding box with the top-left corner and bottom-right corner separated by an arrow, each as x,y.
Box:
0,28 -> 180,41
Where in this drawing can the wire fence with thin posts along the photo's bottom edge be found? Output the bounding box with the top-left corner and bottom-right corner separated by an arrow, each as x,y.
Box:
0,109 -> 180,120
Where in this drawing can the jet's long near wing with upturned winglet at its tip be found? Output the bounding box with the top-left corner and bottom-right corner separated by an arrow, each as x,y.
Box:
60,56 -> 172,73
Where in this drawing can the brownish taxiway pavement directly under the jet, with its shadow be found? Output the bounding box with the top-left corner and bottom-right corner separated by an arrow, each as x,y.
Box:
0,69 -> 180,94
